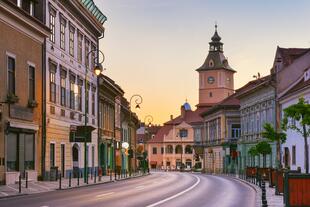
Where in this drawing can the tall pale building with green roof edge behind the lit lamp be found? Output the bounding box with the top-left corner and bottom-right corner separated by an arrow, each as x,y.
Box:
43,0 -> 106,178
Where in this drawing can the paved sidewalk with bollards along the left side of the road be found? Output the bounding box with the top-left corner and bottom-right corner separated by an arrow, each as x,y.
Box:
0,171 -> 148,199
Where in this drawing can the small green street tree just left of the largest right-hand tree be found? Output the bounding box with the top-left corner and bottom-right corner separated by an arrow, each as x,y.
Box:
262,123 -> 286,168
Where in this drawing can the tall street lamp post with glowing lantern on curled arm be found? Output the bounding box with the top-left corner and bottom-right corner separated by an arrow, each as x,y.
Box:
84,49 -> 104,183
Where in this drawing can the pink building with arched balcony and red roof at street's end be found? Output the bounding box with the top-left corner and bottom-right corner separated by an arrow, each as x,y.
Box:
147,102 -> 203,170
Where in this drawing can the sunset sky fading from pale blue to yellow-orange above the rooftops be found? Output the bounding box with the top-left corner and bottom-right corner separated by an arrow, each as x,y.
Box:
95,0 -> 310,124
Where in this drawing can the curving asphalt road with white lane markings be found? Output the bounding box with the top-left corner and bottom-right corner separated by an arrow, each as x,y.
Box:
0,172 -> 256,207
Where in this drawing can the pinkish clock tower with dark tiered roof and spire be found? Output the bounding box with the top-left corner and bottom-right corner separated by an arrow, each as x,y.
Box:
196,25 -> 236,107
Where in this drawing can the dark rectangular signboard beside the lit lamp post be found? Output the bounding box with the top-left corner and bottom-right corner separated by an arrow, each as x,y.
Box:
70,125 -> 95,142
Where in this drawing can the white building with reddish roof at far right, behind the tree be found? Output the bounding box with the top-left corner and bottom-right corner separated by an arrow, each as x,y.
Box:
279,68 -> 310,172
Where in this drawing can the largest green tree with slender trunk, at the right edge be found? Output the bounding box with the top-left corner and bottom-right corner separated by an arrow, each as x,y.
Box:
282,98 -> 310,173
